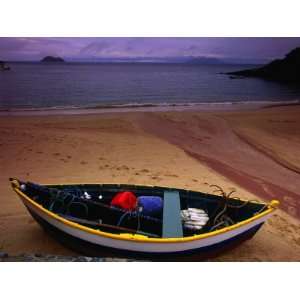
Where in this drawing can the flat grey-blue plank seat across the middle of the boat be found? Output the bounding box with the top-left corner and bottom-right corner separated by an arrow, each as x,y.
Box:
162,191 -> 183,238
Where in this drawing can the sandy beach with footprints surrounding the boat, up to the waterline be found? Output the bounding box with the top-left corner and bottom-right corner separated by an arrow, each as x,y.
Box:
0,105 -> 300,261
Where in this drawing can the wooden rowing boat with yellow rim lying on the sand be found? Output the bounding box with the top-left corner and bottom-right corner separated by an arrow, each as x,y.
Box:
10,178 -> 279,259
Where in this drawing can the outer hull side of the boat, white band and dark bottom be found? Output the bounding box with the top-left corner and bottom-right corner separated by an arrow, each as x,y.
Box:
19,191 -> 270,260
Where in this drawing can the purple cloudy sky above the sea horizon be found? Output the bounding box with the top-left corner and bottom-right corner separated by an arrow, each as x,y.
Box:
0,38 -> 300,62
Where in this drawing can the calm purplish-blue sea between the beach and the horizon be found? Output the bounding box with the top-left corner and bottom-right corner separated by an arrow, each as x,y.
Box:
0,63 -> 300,111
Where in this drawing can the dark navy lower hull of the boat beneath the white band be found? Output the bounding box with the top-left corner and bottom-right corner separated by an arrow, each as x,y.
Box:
27,208 -> 263,261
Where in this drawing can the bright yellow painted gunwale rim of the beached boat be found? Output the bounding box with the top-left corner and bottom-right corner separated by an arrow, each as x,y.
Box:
12,183 -> 279,243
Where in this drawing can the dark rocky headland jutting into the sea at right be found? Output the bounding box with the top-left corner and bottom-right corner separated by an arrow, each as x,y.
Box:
225,47 -> 300,82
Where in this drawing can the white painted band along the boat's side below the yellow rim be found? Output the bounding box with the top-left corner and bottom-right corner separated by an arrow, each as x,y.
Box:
20,195 -> 271,253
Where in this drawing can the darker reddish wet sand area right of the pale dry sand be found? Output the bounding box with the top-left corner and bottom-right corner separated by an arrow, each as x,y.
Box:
141,106 -> 300,219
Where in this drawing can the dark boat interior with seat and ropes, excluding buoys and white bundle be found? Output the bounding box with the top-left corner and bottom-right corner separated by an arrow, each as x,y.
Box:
14,182 -> 267,238
